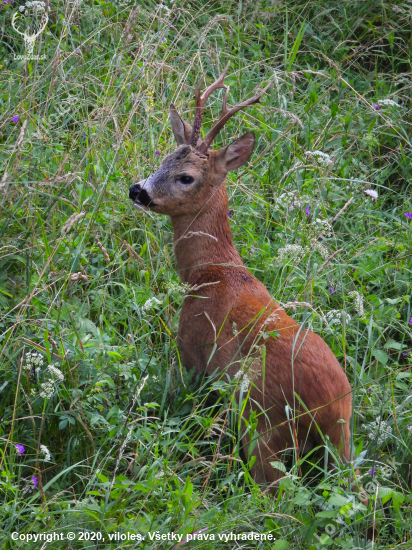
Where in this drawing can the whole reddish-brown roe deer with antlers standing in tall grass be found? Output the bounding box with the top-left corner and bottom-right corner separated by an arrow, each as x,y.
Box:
129,64 -> 360,494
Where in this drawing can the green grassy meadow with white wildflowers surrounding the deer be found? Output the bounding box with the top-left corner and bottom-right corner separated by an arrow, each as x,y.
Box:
0,0 -> 412,550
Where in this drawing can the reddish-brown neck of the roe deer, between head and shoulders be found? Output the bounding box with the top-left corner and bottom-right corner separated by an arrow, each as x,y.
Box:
171,184 -> 243,283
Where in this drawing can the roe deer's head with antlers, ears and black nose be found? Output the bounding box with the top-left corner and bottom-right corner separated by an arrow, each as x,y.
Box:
129,63 -> 268,217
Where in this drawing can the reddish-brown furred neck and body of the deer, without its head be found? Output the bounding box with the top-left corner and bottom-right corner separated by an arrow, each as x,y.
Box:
172,181 -> 351,482
